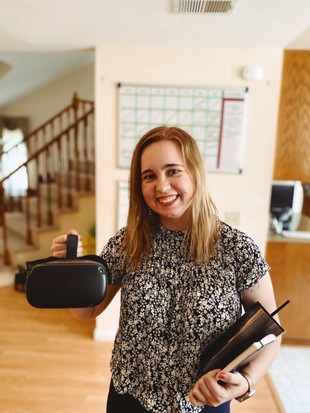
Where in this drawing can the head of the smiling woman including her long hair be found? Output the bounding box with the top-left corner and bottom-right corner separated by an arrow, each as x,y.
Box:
125,126 -> 218,265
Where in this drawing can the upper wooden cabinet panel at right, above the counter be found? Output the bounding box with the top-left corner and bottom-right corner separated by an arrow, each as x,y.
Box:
273,50 -> 310,182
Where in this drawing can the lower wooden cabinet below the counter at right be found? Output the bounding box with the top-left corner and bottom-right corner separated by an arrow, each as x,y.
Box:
266,240 -> 310,345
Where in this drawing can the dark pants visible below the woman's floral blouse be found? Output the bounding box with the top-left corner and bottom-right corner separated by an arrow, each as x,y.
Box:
107,381 -> 230,413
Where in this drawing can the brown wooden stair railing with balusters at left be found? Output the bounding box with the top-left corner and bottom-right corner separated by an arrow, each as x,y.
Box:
0,95 -> 94,265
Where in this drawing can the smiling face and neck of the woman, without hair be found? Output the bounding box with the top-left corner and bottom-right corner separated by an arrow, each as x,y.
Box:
141,140 -> 194,231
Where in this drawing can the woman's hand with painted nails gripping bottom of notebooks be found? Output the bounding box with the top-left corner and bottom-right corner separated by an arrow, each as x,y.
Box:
189,370 -> 248,407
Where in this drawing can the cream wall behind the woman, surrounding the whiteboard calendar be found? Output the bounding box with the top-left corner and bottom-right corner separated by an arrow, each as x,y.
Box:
95,46 -> 283,339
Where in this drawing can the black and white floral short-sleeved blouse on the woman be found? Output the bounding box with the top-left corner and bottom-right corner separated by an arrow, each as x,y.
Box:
101,223 -> 269,413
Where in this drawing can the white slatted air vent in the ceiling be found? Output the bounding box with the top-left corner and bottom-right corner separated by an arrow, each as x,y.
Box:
172,0 -> 239,14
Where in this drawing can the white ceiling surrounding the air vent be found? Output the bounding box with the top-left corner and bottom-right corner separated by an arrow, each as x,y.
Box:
0,0 -> 310,107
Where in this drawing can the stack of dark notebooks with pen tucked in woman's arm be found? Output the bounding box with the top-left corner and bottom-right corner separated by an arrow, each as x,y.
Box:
200,301 -> 289,374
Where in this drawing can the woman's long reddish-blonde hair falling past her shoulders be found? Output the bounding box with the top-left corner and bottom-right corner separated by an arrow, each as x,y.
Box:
123,126 -> 219,268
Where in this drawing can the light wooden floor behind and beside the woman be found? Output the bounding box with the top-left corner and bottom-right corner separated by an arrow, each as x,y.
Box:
0,286 -> 281,413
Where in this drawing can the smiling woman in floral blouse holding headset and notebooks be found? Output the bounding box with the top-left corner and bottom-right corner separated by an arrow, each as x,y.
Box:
52,126 -> 280,413
